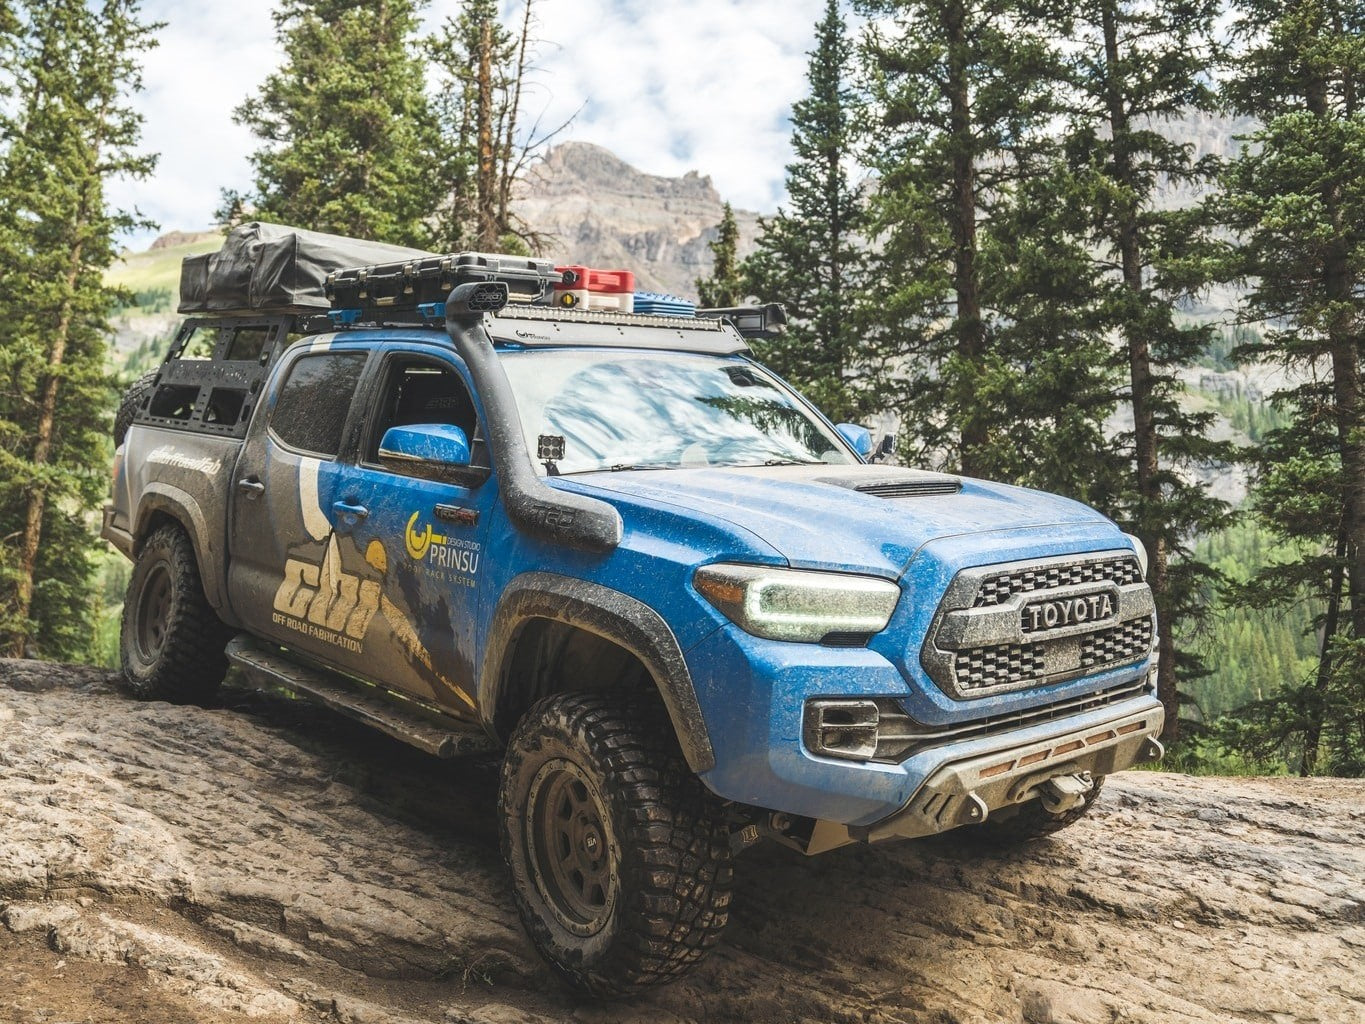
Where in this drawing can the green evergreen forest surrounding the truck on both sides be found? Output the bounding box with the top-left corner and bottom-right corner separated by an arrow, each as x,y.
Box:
0,0 -> 1365,776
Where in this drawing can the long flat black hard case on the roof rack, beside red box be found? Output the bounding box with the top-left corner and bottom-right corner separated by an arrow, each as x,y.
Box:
326,253 -> 560,313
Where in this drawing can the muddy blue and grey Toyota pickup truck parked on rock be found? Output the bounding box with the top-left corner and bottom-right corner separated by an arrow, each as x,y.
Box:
104,222 -> 1163,995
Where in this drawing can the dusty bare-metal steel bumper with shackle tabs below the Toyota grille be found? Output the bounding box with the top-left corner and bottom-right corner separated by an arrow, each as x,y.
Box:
849,698 -> 1164,842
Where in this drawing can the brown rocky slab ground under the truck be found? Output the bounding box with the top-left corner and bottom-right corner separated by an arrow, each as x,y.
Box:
0,662 -> 1365,1024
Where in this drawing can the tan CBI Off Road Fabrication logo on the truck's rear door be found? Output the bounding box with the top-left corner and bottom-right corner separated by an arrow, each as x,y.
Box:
273,537 -> 385,654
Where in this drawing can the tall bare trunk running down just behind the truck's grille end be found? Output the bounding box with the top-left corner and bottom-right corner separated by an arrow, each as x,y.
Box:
1100,0 -> 1181,740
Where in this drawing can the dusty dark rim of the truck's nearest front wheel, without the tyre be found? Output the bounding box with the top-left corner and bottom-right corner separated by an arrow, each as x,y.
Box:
526,760 -> 620,935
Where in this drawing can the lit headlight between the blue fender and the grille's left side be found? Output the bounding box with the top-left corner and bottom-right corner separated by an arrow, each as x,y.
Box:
692,565 -> 901,643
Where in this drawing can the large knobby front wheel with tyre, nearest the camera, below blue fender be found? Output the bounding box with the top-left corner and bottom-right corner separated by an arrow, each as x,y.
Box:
498,694 -> 733,995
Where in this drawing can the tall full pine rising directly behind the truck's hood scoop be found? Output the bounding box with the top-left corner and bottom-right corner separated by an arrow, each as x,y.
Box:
859,0 -> 1117,501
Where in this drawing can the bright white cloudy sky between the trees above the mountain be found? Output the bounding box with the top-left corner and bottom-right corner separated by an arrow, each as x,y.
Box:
111,0 -> 823,247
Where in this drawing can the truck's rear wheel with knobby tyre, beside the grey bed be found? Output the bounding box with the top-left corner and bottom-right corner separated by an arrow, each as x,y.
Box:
119,524 -> 229,703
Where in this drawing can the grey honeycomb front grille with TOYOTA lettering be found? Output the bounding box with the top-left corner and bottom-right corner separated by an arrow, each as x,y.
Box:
920,552 -> 1155,700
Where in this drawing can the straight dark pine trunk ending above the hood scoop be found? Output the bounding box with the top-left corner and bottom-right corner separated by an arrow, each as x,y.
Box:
945,3 -> 988,477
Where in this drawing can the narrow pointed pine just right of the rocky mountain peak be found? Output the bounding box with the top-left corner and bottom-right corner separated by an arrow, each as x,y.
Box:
744,0 -> 876,421
